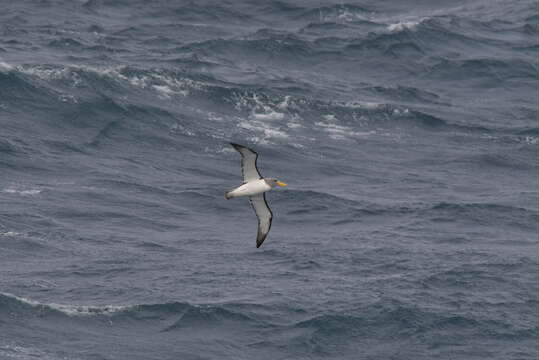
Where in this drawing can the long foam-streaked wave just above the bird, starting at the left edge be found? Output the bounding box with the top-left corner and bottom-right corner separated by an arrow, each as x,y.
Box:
0,59 -> 516,147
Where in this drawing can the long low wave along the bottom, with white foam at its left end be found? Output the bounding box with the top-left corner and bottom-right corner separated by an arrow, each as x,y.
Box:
0,292 -> 538,344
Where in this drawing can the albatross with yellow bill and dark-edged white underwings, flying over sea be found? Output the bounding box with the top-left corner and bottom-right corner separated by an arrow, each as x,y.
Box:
225,143 -> 286,248
